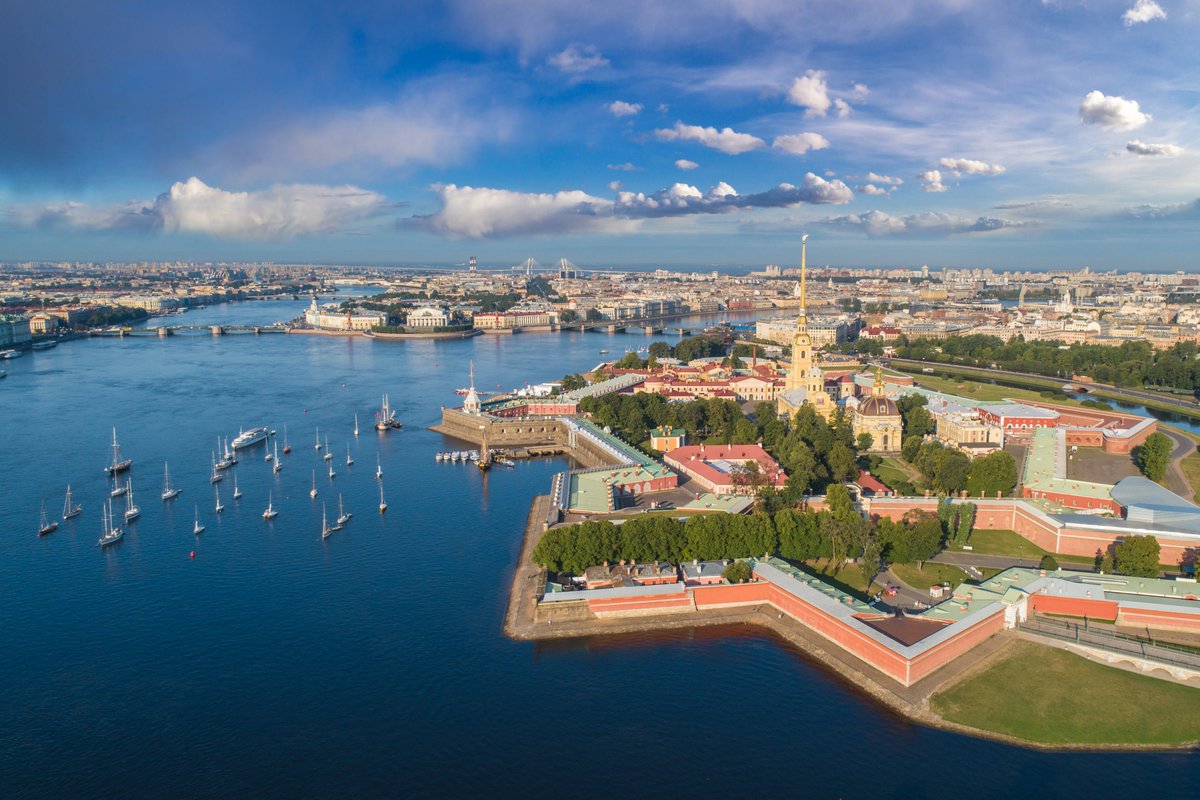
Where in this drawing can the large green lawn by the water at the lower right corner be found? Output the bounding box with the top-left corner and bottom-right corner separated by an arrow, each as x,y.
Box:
930,642 -> 1200,745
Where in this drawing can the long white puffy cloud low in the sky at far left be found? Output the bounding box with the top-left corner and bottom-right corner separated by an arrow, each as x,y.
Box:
8,178 -> 388,239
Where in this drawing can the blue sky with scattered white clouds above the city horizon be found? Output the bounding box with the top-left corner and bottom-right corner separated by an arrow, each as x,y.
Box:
0,0 -> 1200,271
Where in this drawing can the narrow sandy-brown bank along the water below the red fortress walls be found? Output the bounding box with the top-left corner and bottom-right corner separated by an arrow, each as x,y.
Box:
504,495 -> 1193,751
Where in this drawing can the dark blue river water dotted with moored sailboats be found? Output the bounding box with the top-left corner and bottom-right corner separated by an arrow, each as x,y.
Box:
0,300 -> 1200,798
